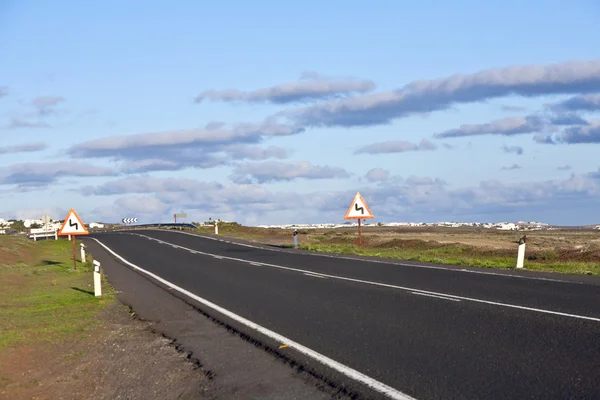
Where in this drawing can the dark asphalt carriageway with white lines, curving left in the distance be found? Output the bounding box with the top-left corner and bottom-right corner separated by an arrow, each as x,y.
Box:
88,230 -> 600,399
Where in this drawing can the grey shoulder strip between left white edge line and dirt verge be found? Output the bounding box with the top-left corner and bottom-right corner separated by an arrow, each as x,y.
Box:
86,240 -> 344,399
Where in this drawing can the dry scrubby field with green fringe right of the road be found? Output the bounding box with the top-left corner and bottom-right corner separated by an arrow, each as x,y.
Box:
190,223 -> 600,276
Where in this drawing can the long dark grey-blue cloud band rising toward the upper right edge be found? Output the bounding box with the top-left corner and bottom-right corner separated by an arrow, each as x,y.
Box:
280,60 -> 600,126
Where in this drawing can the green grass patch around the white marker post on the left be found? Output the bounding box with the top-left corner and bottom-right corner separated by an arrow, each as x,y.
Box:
0,236 -> 114,352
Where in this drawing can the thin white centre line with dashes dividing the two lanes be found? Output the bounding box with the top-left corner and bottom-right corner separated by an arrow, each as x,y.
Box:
127,233 -> 600,322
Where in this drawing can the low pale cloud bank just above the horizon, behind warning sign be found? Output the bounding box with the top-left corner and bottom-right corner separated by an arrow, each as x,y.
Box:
76,170 -> 600,223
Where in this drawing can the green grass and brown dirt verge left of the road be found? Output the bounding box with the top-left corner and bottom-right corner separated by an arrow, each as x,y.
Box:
0,236 -> 207,399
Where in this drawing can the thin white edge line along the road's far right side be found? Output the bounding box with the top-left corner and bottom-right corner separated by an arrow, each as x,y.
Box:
161,229 -> 583,285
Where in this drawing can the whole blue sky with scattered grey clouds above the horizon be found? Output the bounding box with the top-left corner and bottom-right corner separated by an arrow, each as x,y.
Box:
0,0 -> 600,225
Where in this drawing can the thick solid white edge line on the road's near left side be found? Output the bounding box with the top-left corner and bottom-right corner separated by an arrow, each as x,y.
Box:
89,238 -> 415,400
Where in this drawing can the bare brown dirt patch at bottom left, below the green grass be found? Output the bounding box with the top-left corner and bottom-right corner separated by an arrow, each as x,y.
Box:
0,303 -> 211,400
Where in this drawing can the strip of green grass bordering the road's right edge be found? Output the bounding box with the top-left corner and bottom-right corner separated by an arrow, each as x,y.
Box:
300,243 -> 600,276
